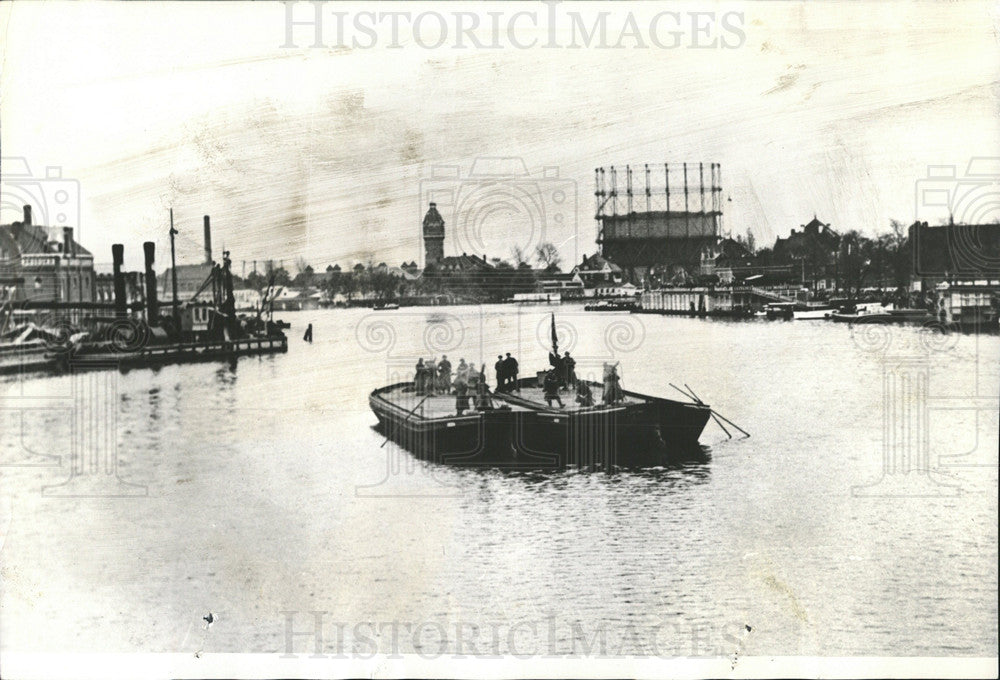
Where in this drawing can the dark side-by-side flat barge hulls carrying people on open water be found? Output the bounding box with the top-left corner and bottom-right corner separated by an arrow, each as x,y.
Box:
368,378 -> 711,470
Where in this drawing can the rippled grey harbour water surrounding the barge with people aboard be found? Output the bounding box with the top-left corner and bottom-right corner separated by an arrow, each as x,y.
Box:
0,306 -> 1000,656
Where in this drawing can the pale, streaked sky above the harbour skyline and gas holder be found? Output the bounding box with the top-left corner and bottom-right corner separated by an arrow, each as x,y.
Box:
0,2 -> 1000,273
